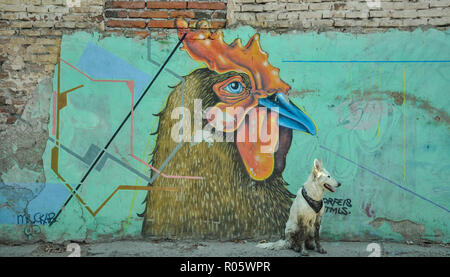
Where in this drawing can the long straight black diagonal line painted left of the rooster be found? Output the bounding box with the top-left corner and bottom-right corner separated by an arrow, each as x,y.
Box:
49,34 -> 186,226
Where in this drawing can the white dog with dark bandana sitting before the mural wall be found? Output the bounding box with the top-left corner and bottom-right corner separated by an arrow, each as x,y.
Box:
257,159 -> 341,256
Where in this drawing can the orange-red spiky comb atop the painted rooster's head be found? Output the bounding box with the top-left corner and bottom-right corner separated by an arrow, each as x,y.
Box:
176,18 -> 291,94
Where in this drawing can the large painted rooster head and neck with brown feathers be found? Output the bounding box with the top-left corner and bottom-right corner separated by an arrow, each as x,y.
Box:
141,19 -> 317,239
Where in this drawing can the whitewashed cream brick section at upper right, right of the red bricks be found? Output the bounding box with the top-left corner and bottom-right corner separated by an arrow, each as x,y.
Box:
228,0 -> 450,32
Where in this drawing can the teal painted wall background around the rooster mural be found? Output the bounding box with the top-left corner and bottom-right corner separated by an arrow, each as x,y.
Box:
0,27 -> 450,242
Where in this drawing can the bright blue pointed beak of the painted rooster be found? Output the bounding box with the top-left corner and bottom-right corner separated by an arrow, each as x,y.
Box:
258,93 -> 317,136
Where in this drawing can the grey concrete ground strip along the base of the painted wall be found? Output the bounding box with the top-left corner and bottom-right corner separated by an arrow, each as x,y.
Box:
0,237 -> 450,257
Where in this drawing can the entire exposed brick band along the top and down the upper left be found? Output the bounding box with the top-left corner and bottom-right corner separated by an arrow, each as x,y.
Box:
0,0 -> 450,132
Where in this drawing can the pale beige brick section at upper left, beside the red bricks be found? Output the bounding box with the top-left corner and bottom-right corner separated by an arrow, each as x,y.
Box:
0,0 -> 103,129
